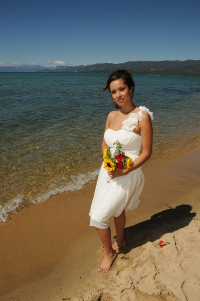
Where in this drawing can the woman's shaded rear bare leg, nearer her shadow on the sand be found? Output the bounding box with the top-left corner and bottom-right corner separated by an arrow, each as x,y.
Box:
112,211 -> 126,250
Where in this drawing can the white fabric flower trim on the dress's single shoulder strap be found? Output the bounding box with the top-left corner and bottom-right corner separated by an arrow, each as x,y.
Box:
122,106 -> 154,132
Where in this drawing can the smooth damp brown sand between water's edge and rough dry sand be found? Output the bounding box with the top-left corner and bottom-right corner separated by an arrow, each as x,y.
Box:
0,150 -> 200,301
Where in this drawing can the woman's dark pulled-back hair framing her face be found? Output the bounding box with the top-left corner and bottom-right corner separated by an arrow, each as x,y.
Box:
103,70 -> 135,108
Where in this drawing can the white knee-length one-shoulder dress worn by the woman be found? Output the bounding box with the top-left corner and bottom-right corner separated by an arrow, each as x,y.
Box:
89,107 -> 153,229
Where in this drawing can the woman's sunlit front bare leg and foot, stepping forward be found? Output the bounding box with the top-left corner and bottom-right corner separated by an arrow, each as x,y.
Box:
96,228 -> 116,273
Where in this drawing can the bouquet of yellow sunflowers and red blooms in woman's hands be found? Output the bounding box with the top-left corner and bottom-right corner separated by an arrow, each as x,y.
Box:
103,140 -> 132,172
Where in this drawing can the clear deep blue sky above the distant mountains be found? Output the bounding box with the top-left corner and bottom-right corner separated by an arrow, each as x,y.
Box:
0,0 -> 200,66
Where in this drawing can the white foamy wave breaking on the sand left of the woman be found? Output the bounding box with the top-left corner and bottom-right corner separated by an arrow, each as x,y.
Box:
0,169 -> 99,222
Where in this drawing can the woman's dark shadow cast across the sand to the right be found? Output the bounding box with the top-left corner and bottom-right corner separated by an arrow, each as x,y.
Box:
121,205 -> 196,254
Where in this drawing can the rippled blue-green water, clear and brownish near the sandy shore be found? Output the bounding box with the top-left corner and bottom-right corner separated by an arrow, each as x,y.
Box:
0,73 -> 200,222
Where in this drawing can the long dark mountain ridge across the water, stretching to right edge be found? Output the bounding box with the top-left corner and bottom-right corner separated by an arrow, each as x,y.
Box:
39,60 -> 200,76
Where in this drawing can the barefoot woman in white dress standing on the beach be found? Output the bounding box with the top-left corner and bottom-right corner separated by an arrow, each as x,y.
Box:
90,70 -> 153,273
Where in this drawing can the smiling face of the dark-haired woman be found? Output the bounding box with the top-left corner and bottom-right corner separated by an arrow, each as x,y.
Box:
110,78 -> 133,107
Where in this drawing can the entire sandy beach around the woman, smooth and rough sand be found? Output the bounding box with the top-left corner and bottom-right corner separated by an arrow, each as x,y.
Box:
0,150 -> 200,301
